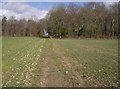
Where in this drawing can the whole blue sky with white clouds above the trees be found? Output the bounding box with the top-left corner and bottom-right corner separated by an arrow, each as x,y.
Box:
0,0 -> 118,19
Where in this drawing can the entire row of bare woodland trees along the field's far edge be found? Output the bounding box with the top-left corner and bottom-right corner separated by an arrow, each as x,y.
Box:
2,2 -> 119,38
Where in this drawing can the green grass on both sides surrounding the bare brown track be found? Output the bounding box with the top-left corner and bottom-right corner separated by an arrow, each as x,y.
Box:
2,37 -> 118,87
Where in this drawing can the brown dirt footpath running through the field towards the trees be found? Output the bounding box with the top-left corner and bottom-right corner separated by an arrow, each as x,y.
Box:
37,41 -> 90,87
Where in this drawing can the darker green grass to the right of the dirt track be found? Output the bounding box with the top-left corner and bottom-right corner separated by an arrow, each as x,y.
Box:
56,39 -> 118,86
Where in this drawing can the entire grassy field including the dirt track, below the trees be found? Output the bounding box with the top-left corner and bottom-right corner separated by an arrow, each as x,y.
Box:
2,37 -> 118,87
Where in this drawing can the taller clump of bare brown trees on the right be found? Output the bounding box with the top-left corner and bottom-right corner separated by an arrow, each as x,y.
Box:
46,2 -> 118,38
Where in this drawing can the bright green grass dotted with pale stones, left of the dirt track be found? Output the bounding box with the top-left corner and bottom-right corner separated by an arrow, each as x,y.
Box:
2,38 -> 45,86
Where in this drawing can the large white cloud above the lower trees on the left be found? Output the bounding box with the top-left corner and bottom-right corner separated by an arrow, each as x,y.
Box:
0,2 -> 48,19
